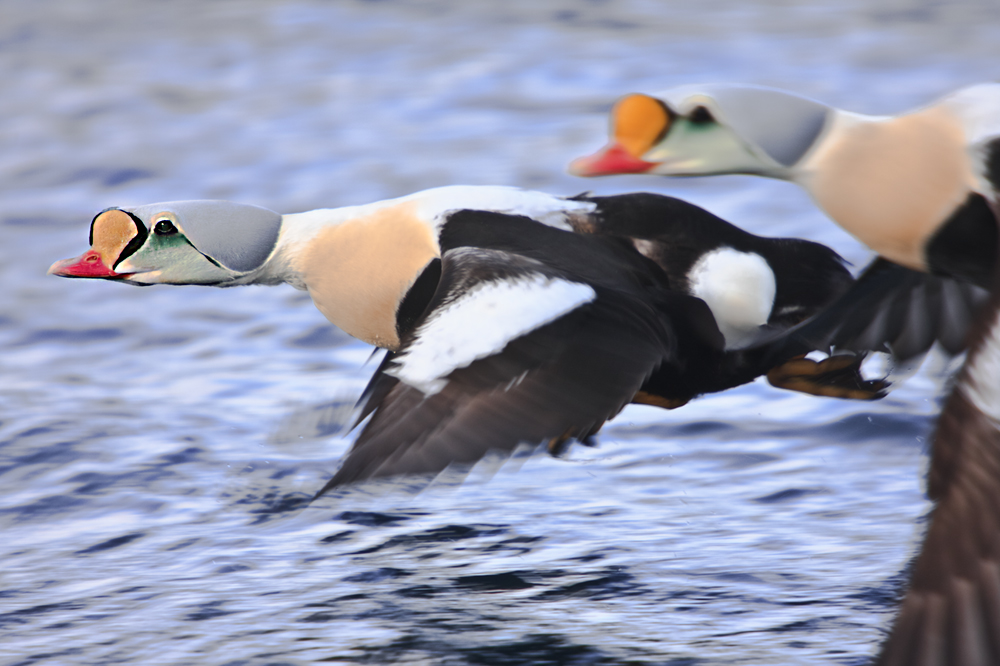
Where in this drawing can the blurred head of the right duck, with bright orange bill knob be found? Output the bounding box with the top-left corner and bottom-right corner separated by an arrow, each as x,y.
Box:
569,84 -> 832,178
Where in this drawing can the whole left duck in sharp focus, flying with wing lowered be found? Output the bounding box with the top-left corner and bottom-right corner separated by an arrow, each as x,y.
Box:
49,186 -> 884,494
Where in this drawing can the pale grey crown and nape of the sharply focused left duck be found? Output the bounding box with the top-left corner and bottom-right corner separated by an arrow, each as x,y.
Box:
132,200 -> 281,273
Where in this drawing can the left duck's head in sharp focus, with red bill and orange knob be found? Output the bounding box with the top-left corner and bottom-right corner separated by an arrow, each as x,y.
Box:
49,201 -> 282,285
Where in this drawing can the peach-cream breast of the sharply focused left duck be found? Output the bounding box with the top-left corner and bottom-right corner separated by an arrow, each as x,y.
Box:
296,201 -> 440,349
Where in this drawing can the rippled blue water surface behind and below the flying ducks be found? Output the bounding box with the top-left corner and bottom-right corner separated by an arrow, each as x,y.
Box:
0,0 -> 1000,666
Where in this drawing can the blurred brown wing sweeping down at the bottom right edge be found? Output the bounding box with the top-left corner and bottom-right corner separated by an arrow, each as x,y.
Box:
877,303 -> 1000,666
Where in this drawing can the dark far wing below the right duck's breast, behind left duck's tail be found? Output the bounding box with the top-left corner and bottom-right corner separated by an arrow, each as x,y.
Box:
761,257 -> 989,361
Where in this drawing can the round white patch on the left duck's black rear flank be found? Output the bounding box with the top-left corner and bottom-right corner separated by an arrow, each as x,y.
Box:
688,247 -> 777,349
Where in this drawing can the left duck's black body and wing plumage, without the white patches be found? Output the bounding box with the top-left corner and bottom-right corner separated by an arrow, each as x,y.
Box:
319,195 -> 864,495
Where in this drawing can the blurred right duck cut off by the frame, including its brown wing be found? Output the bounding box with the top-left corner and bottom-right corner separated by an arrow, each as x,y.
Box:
571,84 -> 1000,666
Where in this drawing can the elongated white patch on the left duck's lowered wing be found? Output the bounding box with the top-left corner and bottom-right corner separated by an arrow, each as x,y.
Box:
386,273 -> 597,395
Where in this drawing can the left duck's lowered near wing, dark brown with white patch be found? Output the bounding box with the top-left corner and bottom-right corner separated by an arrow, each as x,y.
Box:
317,247 -> 688,496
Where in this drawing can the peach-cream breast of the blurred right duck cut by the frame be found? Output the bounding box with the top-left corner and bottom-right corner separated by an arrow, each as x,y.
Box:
801,107 -> 975,270
